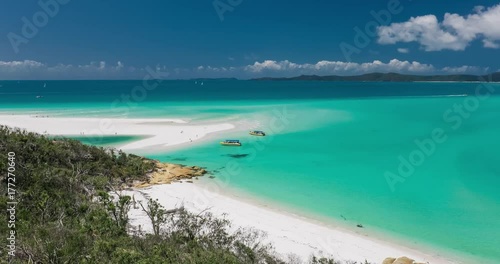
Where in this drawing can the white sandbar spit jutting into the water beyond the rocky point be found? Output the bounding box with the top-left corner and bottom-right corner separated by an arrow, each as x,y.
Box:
0,114 -> 235,150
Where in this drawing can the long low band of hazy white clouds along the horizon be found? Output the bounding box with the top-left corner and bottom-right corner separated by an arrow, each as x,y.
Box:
0,59 -> 489,80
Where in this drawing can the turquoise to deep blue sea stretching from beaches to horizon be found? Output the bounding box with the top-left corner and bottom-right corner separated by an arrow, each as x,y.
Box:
0,81 -> 500,263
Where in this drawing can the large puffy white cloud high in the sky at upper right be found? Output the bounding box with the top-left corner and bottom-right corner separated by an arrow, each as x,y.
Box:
378,4 -> 500,51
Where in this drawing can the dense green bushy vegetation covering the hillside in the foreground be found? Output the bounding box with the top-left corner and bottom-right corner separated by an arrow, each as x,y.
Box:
0,126 -> 360,264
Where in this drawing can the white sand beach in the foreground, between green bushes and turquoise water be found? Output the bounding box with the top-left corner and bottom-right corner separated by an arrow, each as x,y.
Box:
123,182 -> 459,264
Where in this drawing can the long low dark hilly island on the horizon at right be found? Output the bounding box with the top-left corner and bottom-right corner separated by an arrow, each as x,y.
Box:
251,72 -> 500,82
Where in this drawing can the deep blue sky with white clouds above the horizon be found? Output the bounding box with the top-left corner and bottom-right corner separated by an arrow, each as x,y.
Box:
0,0 -> 500,79
